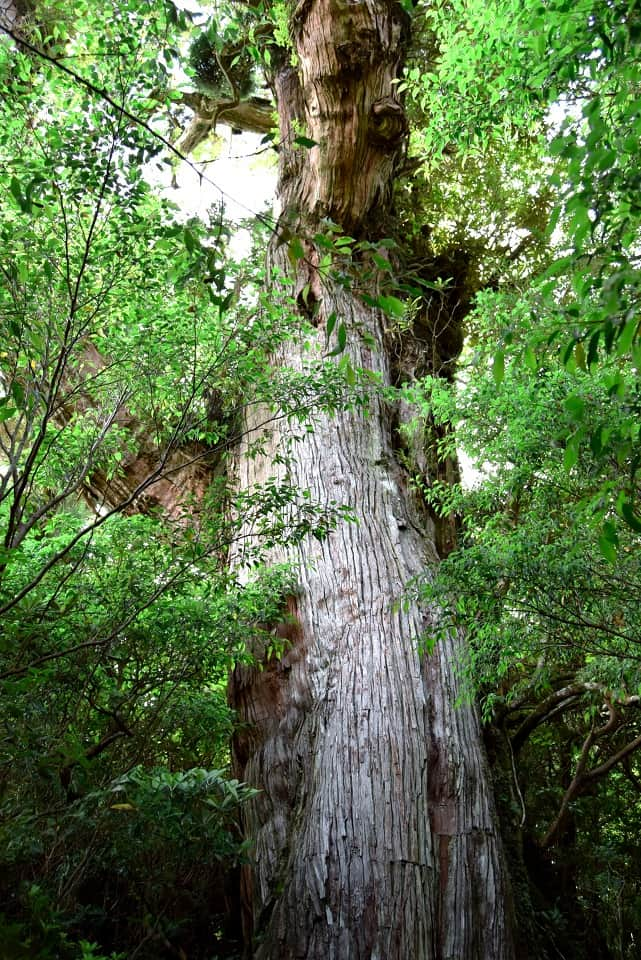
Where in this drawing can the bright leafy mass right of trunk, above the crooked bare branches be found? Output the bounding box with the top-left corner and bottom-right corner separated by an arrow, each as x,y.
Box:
410,342 -> 641,695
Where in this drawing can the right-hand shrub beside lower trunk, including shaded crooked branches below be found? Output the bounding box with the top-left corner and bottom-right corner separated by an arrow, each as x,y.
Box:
412,294 -> 641,958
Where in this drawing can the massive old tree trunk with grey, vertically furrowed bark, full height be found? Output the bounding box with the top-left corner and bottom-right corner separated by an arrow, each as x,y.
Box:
230,0 -> 514,960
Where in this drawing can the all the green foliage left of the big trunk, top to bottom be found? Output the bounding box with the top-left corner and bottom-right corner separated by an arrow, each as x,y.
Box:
0,2 -> 365,960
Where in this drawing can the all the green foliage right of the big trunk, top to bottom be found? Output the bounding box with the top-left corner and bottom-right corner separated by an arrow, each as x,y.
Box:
404,0 -> 641,958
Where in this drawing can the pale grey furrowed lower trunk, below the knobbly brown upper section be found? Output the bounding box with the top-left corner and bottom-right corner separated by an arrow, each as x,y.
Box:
231,291 -> 513,960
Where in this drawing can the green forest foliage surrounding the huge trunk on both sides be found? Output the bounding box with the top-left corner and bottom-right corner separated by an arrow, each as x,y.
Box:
0,0 -> 641,960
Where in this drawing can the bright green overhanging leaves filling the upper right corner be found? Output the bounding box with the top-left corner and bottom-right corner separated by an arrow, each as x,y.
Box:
405,0 -> 641,542
